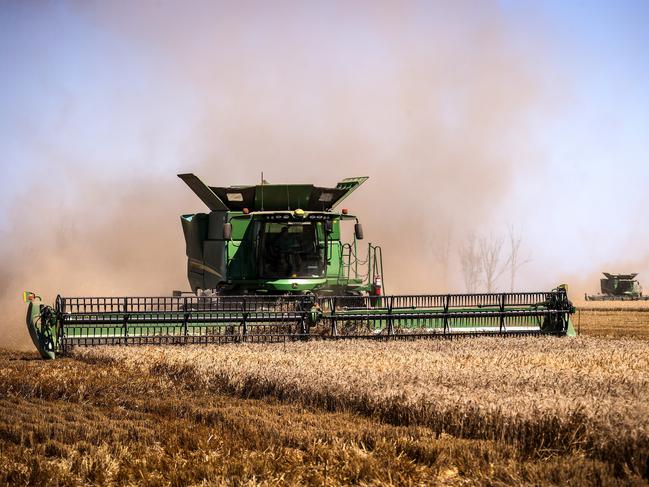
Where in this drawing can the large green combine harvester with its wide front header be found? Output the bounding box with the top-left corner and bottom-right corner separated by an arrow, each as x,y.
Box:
24,174 -> 574,359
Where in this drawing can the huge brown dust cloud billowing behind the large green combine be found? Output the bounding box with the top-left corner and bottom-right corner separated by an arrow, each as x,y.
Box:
0,2 -> 572,347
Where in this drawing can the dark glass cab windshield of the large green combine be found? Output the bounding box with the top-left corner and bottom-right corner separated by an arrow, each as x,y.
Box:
258,222 -> 325,278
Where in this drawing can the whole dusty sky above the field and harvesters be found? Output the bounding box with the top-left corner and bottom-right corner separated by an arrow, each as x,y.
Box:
0,0 -> 649,306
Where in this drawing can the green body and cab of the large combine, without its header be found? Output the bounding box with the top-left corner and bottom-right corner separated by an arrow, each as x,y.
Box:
179,174 -> 374,295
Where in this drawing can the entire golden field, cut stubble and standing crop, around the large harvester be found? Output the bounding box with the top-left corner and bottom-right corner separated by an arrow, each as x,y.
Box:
0,311 -> 649,485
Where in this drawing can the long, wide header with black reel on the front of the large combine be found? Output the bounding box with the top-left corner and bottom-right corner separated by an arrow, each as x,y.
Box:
26,287 -> 574,359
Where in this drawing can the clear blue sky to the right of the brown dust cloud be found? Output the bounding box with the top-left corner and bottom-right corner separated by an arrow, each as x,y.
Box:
508,2 -> 649,282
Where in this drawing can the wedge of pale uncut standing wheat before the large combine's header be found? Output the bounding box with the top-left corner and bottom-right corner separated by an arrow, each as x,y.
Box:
77,338 -> 649,475
